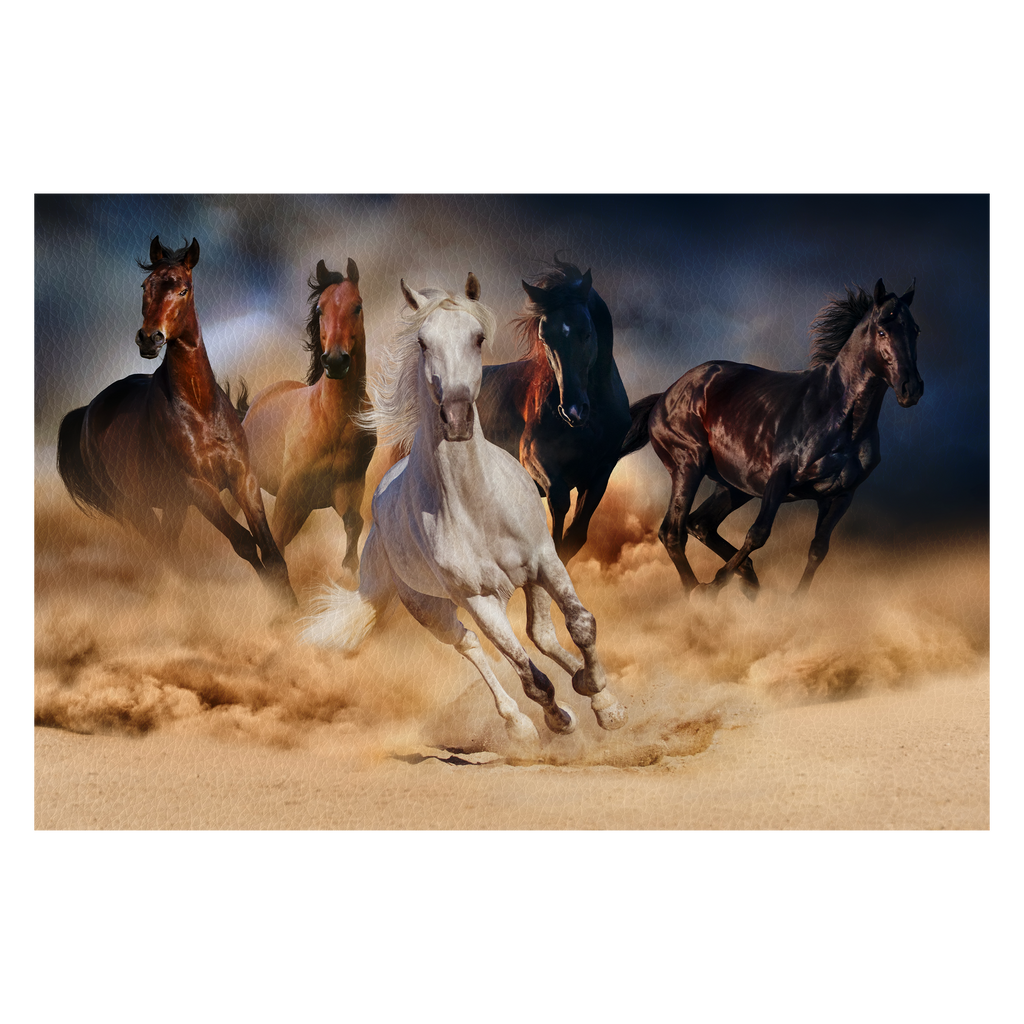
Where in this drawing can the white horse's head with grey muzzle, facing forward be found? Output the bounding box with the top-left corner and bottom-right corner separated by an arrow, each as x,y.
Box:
401,273 -> 495,441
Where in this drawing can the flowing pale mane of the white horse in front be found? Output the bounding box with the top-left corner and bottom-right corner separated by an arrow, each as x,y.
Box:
353,288 -> 497,454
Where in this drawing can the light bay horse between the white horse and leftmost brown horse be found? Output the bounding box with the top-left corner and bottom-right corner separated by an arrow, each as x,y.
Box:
239,259 -> 376,572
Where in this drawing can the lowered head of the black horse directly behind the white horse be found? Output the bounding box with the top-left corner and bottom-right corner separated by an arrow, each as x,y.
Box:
522,264 -> 597,427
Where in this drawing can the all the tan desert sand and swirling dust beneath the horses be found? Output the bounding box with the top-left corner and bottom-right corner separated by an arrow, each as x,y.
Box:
32,452 -> 992,833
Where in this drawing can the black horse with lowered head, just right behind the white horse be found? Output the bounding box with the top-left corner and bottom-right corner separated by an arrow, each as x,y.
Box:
477,258 -> 630,562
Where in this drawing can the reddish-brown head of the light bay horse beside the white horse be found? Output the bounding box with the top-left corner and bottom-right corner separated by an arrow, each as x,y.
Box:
306,258 -> 367,384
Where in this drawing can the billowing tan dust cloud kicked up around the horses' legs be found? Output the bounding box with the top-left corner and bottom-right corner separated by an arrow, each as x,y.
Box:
32,452 -> 991,766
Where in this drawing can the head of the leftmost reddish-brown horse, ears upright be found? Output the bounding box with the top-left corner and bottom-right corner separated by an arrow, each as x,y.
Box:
135,234 -> 199,359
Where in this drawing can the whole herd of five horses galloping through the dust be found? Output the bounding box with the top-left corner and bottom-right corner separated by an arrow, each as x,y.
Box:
57,238 -> 924,740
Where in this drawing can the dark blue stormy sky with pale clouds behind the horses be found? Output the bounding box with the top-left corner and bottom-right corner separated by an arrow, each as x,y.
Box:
32,191 -> 992,534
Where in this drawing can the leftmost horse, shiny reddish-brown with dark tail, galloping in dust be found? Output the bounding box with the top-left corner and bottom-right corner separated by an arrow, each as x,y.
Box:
57,237 -> 297,604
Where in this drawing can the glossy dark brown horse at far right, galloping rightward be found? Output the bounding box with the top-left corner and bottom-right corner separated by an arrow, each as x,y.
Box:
623,279 -> 925,591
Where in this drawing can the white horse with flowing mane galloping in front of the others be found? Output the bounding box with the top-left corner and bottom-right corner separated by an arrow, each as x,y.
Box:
303,273 -> 627,741
